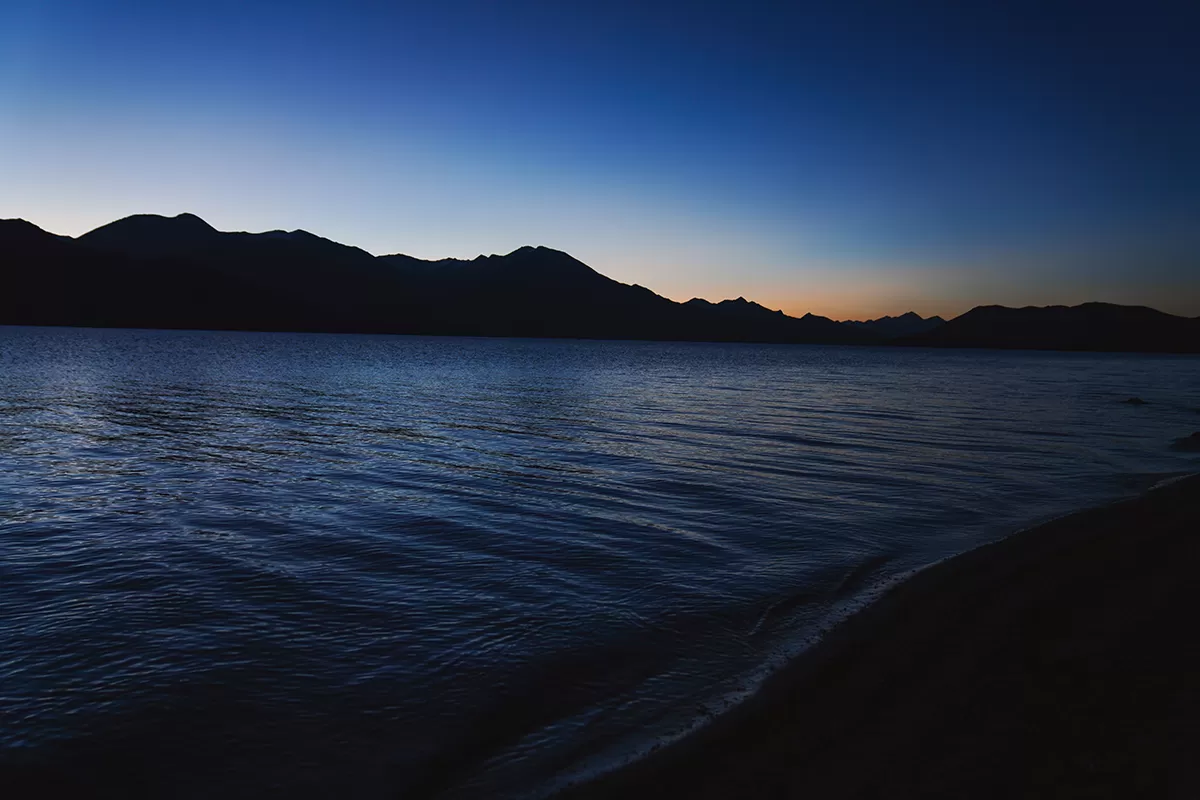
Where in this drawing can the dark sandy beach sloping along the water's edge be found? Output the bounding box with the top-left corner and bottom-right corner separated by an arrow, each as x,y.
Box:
563,476 -> 1200,800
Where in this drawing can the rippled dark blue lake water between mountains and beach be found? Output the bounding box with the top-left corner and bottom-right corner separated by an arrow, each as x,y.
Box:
0,327 -> 1200,798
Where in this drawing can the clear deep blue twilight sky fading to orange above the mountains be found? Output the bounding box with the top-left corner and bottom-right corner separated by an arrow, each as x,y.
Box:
0,0 -> 1200,319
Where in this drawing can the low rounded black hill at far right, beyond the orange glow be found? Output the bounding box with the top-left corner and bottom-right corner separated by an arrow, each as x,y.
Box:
896,302 -> 1200,353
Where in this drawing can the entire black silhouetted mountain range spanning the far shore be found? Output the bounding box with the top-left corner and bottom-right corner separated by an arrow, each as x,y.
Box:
0,213 -> 1200,351
